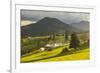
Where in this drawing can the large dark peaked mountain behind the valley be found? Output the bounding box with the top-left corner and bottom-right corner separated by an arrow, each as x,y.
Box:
21,17 -> 81,37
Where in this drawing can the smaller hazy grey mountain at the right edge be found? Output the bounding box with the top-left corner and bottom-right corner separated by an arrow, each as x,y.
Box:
71,21 -> 89,31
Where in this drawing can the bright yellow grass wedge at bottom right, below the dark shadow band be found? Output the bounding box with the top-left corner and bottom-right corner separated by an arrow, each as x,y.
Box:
38,48 -> 89,62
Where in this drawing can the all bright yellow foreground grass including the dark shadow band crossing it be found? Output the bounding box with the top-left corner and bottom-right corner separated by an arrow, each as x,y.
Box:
21,45 -> 89,63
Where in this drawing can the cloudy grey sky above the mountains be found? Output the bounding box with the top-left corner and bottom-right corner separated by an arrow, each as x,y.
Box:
21,10 -> 89,26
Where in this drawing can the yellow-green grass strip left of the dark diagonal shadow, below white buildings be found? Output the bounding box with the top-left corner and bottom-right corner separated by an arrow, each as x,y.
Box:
21,46 -> 65,62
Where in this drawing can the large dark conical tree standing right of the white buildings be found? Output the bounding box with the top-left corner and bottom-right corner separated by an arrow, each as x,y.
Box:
69,33 -> 80,49
